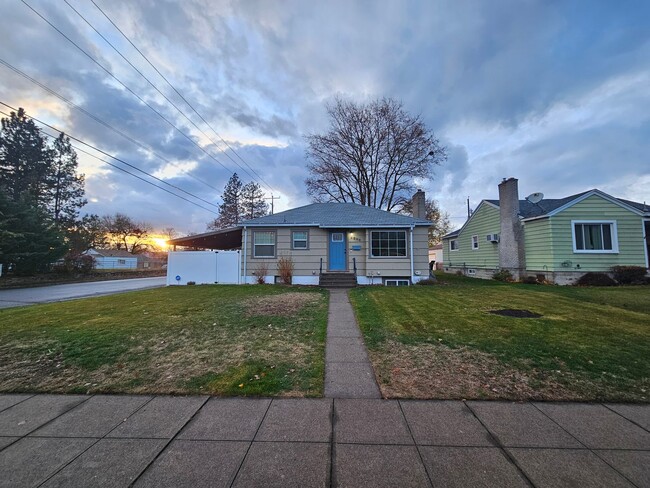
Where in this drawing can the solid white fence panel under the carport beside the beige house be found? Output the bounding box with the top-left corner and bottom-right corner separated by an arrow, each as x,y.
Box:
167,251 -> 240,285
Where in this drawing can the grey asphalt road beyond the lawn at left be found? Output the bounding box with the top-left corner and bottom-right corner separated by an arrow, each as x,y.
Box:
0,276 -> 166,308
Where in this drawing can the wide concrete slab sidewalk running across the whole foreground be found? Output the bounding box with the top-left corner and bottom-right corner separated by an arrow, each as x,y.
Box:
0,395 -> 650,488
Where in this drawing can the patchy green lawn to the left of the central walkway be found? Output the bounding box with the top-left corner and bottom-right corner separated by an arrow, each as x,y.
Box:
0,285 -> 328,396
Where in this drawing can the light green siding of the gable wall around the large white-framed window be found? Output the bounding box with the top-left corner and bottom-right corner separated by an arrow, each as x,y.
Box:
540,195 -> 646,271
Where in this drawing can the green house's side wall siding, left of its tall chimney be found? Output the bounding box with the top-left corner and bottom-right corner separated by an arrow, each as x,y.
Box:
443,203 -> 501,269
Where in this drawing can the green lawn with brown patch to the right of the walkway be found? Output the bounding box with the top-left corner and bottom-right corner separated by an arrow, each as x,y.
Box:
351,274 -> 650,402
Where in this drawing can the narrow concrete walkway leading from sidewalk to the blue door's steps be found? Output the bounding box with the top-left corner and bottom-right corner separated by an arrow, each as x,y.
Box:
325,288 -> 381,398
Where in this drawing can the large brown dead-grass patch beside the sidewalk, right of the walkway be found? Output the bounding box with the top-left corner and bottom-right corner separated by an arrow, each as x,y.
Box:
370,341 -> 602,400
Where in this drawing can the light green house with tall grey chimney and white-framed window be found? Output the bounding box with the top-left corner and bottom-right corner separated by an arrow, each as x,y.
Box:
443,178 -> 650,284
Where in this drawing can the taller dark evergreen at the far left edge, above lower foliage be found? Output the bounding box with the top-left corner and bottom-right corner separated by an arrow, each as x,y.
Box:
0,108 -> 51,206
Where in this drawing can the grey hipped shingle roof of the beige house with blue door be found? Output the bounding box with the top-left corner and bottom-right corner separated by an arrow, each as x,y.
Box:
240,203 -> 431,229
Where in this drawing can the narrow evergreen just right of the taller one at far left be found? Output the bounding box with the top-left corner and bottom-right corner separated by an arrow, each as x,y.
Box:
47,133 -> 87,229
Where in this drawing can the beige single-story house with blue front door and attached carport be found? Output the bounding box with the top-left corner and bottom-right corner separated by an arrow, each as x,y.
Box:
168,191 -> 430,286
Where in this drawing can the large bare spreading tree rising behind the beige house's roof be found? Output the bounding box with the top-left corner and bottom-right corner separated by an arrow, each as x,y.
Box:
305,98 -> 447,211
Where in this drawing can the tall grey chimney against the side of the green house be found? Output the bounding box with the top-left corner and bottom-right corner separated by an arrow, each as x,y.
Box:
499,178 -> 526,279
